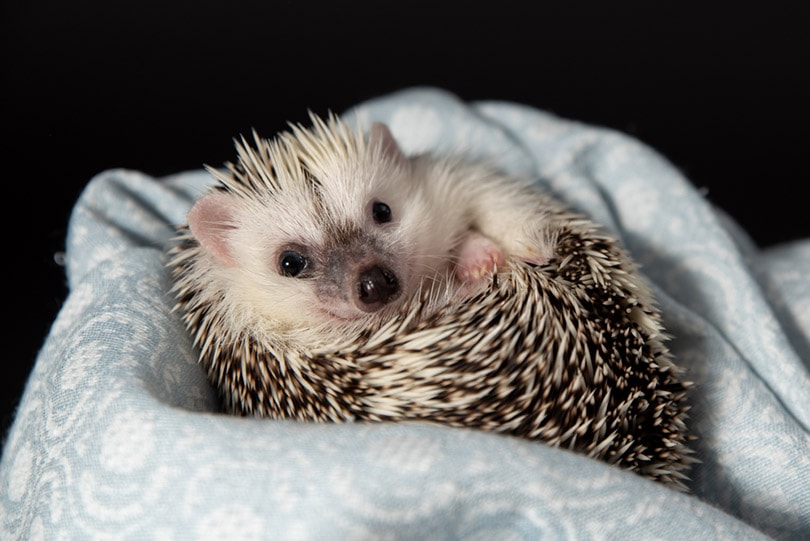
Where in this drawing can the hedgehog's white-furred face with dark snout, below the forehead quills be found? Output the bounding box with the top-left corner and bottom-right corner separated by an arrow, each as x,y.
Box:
189,181 -> 410,328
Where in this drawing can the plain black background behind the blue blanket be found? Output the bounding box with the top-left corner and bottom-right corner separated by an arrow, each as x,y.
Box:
0,0 -> 810,442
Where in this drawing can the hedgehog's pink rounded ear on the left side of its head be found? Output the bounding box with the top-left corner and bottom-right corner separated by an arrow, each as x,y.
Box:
188,192 -> 236,267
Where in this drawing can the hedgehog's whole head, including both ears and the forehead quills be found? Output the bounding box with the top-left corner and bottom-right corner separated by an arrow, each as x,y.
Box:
188,118 -> 455,331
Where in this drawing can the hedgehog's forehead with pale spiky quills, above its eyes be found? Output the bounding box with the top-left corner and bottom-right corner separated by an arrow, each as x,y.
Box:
221,116 -> 409,245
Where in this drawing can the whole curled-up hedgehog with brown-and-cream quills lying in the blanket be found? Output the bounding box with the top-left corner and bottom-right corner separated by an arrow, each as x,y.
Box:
169,115 -> 694,490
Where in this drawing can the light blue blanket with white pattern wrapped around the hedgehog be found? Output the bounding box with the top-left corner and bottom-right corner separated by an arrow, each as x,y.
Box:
0,88 -> 810,541
